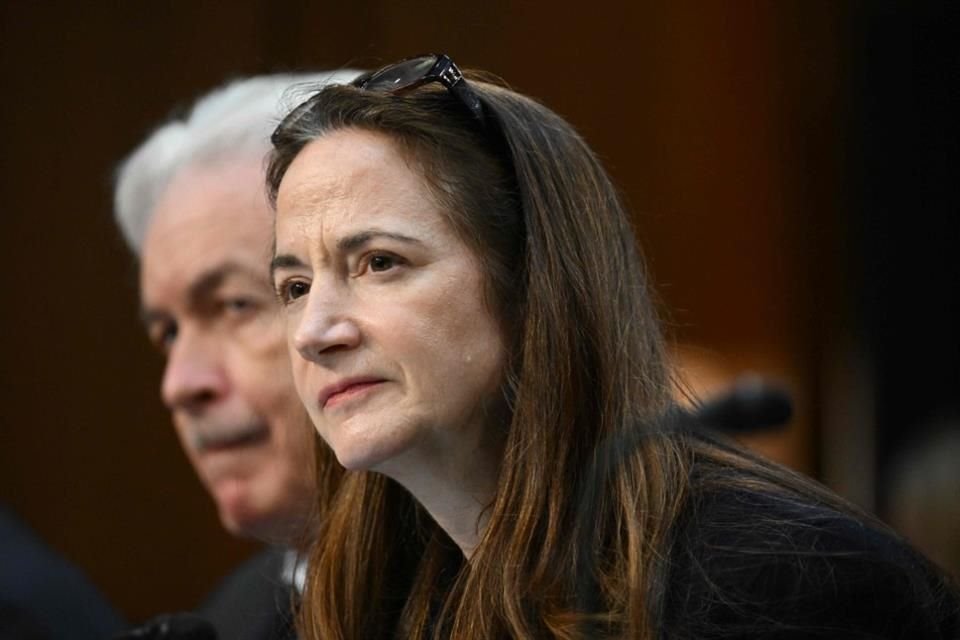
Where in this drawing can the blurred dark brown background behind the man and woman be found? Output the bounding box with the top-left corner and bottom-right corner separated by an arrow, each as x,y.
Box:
0,0 -> 960,620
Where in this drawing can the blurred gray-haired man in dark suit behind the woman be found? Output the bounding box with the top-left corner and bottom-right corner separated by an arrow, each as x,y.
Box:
115,72 -> 356,638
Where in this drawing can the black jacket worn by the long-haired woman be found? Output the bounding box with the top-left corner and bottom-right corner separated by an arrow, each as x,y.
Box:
662,490 -> 960,640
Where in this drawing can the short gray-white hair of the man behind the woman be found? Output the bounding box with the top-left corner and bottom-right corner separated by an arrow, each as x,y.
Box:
113,70 -> 358,255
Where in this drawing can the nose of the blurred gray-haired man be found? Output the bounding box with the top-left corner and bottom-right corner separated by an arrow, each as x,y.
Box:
161,331 -> 230,411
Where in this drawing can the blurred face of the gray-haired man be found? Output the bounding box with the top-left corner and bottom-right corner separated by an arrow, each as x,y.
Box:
140,158 -> 314,542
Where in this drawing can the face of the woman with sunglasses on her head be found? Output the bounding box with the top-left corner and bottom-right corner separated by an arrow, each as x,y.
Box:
272,129 -> 505,477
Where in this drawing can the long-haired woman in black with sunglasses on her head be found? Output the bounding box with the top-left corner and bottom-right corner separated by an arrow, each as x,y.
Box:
268,56 -> 957,638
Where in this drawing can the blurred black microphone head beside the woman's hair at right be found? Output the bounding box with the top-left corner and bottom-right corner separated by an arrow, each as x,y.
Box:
694,375 -> 793,434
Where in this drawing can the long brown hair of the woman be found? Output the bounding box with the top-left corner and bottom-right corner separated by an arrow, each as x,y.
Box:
268,73 -> 876,639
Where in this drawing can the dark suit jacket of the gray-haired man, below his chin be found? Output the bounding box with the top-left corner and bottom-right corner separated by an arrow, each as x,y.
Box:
197,549 -> 296,640
